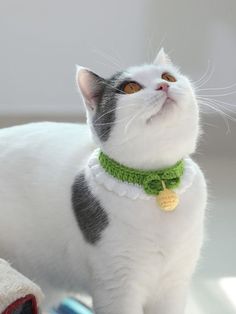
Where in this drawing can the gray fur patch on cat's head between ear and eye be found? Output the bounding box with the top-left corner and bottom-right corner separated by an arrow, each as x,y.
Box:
93,72 -> 122,142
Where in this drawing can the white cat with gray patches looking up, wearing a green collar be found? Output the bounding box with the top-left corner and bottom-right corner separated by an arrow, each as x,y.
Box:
0,49 -> 207,314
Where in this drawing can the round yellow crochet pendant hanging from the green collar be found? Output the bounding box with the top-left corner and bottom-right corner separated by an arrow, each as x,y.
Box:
156,181 -> 179,212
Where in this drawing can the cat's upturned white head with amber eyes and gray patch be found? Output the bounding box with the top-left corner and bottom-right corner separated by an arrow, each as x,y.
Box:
76,49 -> 199,169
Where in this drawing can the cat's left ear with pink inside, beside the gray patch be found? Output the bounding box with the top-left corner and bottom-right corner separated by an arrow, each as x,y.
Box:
76,66 -> 105,111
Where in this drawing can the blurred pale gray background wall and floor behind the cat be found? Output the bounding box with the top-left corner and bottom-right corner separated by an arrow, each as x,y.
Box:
0,0 -> 236,314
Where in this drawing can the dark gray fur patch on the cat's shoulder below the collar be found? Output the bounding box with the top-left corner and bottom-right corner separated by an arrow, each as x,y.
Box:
72,174 -> 109,244
